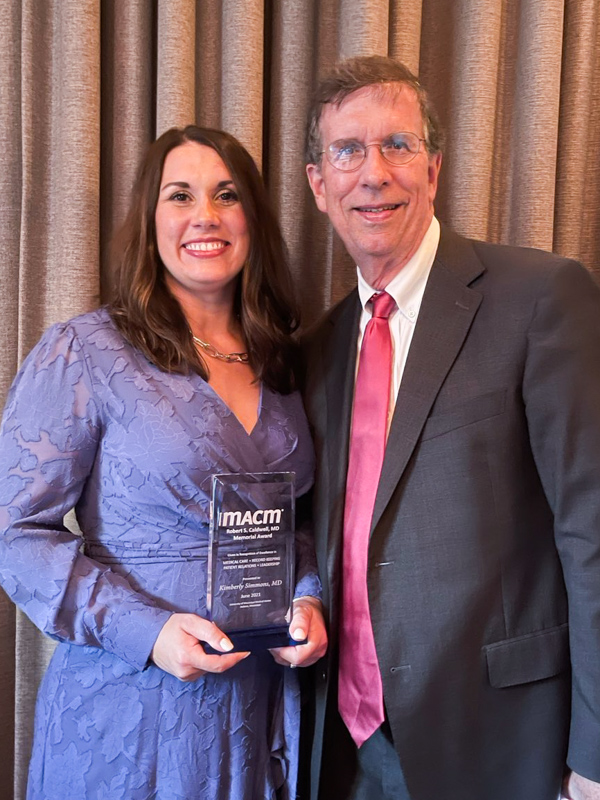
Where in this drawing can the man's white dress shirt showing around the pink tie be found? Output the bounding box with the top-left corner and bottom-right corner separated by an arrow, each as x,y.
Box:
356,217 -> 440,433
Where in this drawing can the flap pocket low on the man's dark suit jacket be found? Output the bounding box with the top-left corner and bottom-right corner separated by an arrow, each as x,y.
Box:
483,622 -> 569,689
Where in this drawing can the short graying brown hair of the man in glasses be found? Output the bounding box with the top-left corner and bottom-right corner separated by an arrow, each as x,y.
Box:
306,56 -> 444,164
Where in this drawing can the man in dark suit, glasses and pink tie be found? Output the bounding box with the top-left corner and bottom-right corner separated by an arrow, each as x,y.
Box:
305,57 -> 600,800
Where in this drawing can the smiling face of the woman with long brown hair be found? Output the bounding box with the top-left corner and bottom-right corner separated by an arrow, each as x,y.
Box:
155,142 -> 250,305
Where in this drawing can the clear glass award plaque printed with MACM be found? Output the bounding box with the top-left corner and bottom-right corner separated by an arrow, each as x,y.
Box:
207,472 -> 299,652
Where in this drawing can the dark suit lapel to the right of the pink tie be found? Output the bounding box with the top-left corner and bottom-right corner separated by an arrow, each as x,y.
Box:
371,229 -> 484,533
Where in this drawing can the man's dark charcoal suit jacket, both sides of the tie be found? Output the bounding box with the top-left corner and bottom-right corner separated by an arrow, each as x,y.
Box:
305,229 -> 600,800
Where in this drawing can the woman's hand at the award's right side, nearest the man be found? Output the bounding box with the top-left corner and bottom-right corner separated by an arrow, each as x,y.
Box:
271,597 -> 327,667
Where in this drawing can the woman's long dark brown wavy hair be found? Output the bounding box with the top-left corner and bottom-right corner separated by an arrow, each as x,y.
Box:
109,125 -> 299,393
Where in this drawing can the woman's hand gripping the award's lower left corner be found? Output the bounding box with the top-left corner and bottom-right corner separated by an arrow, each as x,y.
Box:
155,614 -> 250,681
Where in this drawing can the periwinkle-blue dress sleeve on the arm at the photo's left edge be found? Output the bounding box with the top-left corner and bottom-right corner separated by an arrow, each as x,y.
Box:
0,325 -> 171,670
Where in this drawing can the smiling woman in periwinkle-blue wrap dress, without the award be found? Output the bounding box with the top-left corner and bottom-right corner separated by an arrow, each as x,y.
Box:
0,126 -> 326,800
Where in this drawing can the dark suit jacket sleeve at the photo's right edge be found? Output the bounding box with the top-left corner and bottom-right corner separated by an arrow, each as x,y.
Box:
523,261 -> 600,781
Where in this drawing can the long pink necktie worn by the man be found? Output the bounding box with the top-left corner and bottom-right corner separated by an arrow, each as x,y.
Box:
338,292 -> 396,747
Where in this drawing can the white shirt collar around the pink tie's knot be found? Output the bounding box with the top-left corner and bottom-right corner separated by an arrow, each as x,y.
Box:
356,217 -> 440,323
